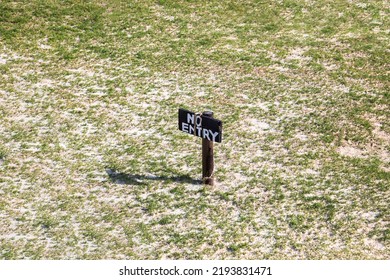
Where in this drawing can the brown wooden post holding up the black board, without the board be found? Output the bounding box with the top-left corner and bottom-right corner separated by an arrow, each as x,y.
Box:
202,111 -> 214,186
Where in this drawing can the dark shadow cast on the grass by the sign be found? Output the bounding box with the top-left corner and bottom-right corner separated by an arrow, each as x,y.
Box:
106,168 -> 202,185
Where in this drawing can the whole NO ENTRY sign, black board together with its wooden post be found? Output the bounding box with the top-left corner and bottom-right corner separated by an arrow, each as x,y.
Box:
179,109 -> 222,186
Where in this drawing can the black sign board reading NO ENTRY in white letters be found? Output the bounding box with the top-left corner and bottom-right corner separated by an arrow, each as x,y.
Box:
179,109 -> 222,143
